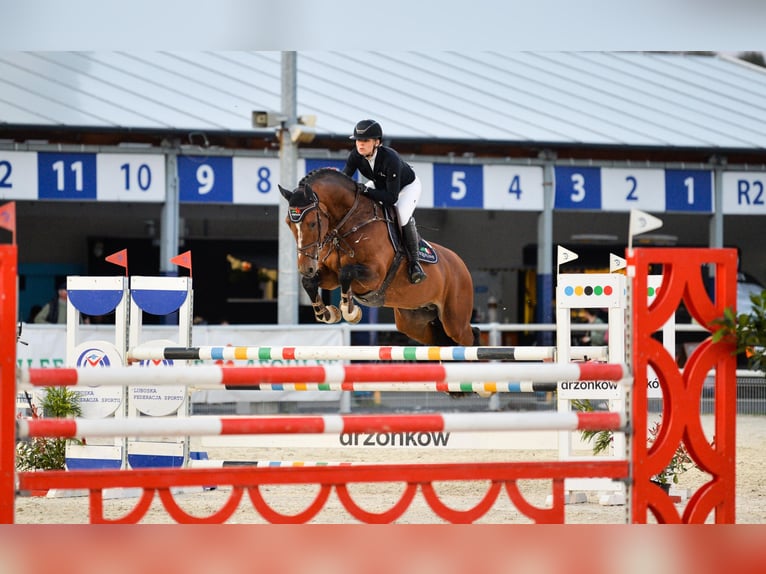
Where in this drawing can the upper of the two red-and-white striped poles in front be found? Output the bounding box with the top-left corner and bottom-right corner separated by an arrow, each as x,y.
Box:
19,363 -> 629,387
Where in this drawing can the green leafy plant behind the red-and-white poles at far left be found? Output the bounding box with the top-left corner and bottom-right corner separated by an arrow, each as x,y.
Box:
16,387 -> 81,471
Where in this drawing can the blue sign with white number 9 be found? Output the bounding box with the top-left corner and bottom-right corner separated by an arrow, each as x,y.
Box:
178,155 -> 233,203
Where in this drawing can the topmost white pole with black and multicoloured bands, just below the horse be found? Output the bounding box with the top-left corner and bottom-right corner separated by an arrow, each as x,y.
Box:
128,345 -> 607,361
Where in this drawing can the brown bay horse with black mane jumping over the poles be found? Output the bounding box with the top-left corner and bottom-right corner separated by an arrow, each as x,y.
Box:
279,168 -> 479,346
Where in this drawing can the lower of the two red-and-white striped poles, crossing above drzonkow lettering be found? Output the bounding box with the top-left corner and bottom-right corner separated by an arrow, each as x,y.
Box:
16,411 -> 626,438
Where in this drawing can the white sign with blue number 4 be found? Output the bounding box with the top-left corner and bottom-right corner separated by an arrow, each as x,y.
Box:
484,165 -> 543,211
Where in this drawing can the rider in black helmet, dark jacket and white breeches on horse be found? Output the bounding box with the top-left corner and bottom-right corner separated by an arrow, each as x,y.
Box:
343,120 -> 426,283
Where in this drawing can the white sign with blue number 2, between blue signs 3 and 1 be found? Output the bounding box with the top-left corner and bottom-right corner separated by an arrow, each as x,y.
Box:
601,168 -> 665,211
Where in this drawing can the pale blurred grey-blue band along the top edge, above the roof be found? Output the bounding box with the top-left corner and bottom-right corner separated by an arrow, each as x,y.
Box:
0,0 -> 766,51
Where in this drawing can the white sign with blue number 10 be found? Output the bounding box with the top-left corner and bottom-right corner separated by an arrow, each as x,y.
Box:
96,153 -> 165,203
